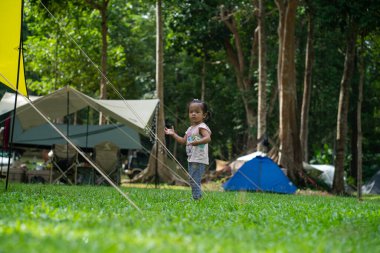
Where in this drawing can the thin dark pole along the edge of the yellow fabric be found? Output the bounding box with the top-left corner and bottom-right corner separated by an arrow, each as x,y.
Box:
5,1 -> 24,190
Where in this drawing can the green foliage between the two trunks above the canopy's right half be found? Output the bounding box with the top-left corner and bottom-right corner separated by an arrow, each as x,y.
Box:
105,0 -> 156,99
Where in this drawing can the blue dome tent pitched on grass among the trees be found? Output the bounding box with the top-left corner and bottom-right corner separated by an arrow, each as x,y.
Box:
223,156 -> 297,194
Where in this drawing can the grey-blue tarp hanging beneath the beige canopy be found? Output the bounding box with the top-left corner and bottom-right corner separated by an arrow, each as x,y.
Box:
13,121 -> 142,149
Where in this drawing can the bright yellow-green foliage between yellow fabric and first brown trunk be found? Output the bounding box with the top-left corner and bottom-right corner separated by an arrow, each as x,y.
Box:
24,2 -> 100,94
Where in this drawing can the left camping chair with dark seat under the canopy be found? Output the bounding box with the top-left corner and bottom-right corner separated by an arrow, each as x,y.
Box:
50,144 -> 78,184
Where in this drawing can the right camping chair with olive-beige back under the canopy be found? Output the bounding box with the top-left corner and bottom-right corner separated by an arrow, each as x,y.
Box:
94,141 -> 121,184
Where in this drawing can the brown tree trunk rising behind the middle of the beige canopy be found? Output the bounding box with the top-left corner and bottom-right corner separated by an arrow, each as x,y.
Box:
86,0 -> 110,124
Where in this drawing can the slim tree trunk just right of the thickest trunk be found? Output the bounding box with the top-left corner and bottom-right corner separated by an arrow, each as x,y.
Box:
300,1 -> 314,162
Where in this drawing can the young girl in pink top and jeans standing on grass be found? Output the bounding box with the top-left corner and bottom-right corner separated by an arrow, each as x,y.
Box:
165,99 -> 211,200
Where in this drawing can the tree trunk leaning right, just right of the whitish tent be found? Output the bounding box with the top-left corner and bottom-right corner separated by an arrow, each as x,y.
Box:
333,18 -> 356,194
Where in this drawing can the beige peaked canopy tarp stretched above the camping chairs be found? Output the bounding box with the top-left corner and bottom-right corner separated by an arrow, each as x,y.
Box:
0,86 -> 159,135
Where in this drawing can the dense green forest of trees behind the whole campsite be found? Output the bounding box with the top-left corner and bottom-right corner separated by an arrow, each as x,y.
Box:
0,0 -> 380,193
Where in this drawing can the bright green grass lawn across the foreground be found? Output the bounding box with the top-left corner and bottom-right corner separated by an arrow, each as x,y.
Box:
0,183 -> 380,253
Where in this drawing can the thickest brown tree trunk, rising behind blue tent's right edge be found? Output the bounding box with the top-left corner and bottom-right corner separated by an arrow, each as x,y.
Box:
276,0 -> 302,183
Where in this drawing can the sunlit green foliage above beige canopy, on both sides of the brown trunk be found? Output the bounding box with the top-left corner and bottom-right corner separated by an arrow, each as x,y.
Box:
24,0 -> 155,99
